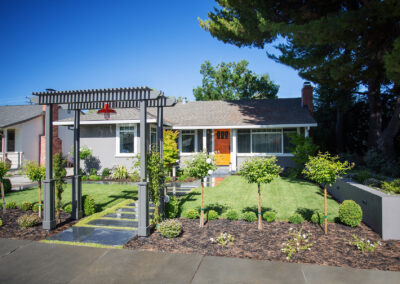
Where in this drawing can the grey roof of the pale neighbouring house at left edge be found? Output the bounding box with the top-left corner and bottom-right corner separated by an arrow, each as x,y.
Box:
0,105 -> 44,128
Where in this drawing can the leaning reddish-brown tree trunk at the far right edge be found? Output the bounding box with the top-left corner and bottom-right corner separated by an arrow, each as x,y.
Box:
378,96 -> 400,160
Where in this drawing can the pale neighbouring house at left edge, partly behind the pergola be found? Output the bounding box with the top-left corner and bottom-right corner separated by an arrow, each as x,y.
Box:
0,105 -> 72,169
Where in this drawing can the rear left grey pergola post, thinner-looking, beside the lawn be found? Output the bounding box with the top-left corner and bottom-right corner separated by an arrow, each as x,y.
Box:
72,110 -> 83,220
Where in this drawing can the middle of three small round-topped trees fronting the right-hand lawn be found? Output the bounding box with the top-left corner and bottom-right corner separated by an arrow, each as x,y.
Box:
239,156 -> 282,230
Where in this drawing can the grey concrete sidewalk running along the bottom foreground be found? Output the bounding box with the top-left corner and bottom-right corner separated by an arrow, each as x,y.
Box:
0,239 -> 400,284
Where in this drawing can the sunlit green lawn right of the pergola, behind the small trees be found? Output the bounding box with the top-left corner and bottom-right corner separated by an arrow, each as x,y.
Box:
180,176 -> 339,222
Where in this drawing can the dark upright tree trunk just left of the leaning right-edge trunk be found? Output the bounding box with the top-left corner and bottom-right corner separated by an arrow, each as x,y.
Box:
368,80 -> 382,147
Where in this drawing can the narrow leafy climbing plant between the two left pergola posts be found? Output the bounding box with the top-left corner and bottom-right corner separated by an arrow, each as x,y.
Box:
53,153 -> 67,222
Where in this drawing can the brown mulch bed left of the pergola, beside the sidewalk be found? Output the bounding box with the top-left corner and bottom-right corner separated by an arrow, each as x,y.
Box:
0,209 -> 77,241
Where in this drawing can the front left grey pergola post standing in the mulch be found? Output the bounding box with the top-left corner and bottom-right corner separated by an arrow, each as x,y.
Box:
43,104 -> 56,230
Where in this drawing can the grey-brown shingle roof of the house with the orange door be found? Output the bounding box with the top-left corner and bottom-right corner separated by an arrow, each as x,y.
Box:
57,98 -> 316,129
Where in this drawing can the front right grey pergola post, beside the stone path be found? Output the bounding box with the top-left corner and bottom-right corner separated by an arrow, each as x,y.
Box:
138,100 -> 149,237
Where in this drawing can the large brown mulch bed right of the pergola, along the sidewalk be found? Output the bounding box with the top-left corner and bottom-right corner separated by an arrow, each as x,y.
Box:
125,219 -> 400,271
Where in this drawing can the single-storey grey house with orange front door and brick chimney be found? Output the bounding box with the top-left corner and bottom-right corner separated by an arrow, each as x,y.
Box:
54,84 -> 317,171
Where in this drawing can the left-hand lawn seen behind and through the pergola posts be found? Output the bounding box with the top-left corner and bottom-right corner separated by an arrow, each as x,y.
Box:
6,184 -> 138,210
